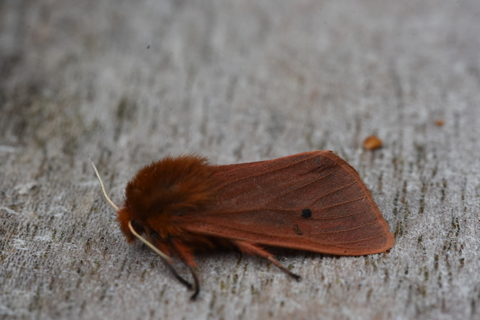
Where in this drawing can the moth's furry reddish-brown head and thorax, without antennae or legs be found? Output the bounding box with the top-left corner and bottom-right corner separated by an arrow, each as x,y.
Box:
118,155 -> 216,241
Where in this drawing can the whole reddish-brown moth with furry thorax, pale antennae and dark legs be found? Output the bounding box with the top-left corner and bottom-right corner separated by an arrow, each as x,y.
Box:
92,151 -> 394,299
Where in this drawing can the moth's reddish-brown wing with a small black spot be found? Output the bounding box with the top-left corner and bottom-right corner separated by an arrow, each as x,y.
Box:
174,151 -> 394,255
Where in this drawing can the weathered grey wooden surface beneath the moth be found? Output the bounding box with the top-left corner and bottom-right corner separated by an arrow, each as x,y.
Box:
0,0 -> 480,319
